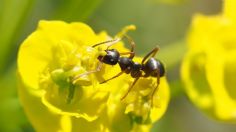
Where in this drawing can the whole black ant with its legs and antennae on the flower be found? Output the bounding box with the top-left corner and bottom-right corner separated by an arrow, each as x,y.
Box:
75,35 -> 165,104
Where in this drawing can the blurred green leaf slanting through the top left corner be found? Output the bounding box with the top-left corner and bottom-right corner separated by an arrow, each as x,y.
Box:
0,0 -> 32,73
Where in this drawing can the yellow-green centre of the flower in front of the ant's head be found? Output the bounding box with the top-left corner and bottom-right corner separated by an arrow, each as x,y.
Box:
40,41 -> 100,104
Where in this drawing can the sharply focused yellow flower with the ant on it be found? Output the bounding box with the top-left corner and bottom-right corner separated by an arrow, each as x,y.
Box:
18,21 -> 169,131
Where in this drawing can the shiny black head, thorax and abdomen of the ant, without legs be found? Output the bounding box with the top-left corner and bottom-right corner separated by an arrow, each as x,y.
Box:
98,49 -> 165,78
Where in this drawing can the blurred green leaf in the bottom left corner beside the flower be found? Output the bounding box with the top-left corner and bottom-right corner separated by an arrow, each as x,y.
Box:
0,64 -> 32,132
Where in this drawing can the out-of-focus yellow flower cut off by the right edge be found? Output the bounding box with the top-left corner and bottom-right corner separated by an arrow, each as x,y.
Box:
181,0 -> 236,123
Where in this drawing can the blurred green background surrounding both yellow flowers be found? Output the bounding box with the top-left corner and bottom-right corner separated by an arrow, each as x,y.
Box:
0,0 -> 236,132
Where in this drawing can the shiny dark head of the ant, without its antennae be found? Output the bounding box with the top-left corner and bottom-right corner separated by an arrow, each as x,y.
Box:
98,49 -> 120,65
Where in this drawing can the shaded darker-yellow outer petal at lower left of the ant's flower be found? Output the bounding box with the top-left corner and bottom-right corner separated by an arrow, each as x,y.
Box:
18,75 -> 61,132
